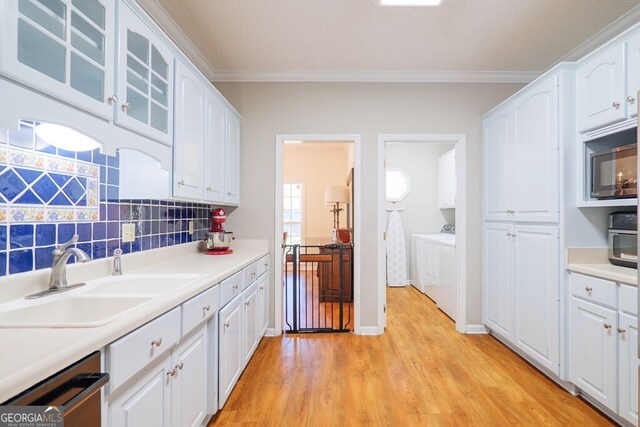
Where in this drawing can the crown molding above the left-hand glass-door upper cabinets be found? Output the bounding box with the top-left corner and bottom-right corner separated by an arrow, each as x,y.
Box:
136,0 -> 216,81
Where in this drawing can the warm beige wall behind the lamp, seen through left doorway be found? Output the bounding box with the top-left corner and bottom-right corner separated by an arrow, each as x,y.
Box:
282,142 -> 353,245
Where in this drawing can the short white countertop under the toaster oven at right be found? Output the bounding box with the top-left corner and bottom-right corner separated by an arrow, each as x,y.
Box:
566,248 -> 638,286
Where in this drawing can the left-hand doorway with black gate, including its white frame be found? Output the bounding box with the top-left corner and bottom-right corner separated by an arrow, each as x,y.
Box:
274,135 -> 360,333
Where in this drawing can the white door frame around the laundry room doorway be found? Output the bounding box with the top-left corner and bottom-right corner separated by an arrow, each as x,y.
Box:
376,134 -> 467,334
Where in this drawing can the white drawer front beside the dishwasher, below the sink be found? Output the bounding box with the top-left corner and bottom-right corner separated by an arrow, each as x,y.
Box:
107,307 -> 180,391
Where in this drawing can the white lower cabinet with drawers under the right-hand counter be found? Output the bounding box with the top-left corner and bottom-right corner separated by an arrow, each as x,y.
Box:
569,273 -> 638,425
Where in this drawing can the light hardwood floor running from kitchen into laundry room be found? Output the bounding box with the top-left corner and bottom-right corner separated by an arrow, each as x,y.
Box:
209,286 -> 612,427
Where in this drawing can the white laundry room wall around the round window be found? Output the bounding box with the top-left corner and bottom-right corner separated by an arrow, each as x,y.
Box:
385,142 -> 455,280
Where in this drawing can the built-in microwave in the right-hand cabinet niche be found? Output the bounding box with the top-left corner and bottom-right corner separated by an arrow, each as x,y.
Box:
591,144 -> 638,199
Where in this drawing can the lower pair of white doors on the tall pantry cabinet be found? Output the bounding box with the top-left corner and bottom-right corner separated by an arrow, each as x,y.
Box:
484,223 -> 560,375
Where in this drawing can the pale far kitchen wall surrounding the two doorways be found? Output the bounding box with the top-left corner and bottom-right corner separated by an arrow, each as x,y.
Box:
216,83 -> 523,327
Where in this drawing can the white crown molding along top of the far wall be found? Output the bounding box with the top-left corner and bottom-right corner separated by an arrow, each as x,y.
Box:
213,70 -> 541,83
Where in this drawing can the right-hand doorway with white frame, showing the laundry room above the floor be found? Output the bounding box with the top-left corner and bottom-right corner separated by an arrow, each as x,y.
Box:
378,134 -> 466,332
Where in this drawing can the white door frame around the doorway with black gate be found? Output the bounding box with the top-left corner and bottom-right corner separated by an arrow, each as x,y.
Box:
273,134 -> 362,336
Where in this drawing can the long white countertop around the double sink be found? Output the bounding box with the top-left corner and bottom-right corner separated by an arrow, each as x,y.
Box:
0,240 -> 269,402
